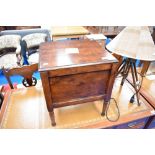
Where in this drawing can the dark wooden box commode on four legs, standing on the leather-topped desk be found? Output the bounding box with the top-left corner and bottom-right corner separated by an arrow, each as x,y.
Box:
39,40 -> 117,125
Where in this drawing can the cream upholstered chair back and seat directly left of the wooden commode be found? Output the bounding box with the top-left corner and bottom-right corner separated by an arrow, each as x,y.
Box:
22,33 -> 47,64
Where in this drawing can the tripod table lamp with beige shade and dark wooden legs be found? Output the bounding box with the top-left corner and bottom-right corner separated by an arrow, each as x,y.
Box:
106,26 -> 155,105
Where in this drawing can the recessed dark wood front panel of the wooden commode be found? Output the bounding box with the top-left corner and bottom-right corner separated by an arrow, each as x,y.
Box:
50,71 -> 109,103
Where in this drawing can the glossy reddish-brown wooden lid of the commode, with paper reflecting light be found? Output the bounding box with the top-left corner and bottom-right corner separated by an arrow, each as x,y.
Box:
39,40 -> 117,71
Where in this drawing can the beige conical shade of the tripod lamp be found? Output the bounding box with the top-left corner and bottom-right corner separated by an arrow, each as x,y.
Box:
106,26 -> 155,61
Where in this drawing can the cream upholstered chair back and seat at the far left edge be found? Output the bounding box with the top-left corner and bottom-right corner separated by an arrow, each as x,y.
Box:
0,35 -> 23,69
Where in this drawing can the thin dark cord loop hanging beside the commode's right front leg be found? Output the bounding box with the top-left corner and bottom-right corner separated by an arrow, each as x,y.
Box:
105,98 -> 120,122
